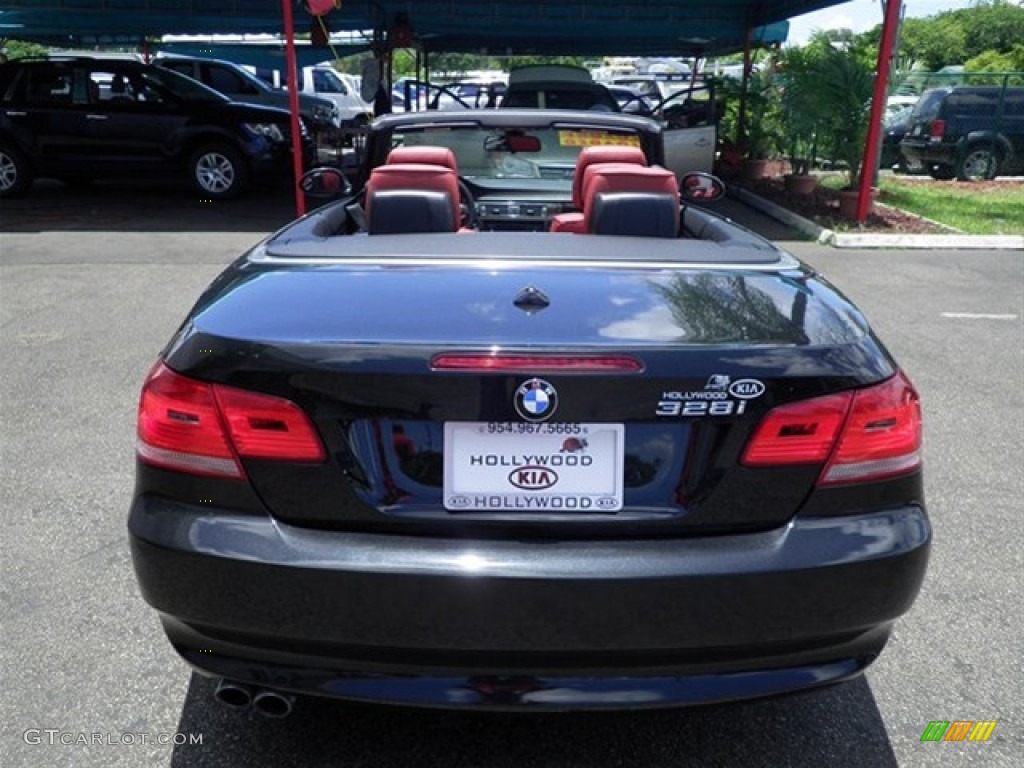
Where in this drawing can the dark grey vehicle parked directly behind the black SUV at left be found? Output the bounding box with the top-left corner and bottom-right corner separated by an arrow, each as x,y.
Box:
155,52 -> 341,139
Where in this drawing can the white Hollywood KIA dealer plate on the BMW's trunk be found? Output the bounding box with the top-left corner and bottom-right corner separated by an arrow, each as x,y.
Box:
444,422 -> 626,514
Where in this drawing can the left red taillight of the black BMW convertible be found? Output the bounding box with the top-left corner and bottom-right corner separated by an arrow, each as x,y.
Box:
137,362 -> 326,479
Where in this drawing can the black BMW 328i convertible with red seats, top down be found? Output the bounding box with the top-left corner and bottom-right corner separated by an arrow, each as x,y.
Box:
128,109 -> 931,717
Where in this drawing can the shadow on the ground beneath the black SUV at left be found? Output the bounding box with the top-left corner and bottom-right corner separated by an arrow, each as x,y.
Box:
0,180 -> 296,232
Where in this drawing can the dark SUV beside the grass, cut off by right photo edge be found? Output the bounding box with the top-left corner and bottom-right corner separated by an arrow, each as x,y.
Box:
900,86 -> 1024,181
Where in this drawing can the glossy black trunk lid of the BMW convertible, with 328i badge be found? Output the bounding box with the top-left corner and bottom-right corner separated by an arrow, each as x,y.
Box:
167,263 -> 892,537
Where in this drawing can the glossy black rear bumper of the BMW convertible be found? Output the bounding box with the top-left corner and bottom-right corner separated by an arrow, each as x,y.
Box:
129,497 -> 931,709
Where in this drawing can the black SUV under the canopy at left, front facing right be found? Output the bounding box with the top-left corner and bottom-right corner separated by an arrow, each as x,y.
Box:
0,57 -> 312,199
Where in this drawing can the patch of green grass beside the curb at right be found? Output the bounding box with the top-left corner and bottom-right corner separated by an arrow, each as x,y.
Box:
879,177 -> 1024,234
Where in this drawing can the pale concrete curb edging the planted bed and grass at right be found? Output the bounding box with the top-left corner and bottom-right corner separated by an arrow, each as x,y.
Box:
729,186 -> 1024,251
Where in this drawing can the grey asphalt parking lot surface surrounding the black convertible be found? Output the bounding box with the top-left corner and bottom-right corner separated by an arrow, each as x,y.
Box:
0,184 -> 1024,768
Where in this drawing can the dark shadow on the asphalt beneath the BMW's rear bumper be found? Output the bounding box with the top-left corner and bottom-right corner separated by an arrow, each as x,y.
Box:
171,675 -> 897,768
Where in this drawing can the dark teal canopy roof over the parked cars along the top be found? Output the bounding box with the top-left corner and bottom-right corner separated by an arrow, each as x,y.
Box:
0,0 -> 841,55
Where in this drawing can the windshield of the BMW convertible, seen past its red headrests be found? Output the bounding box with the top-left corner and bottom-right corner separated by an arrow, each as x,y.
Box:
391,125 -> 641,182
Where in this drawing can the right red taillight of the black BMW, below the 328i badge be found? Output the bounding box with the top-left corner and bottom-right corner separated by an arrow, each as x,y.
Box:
741,373 -> 922,485
